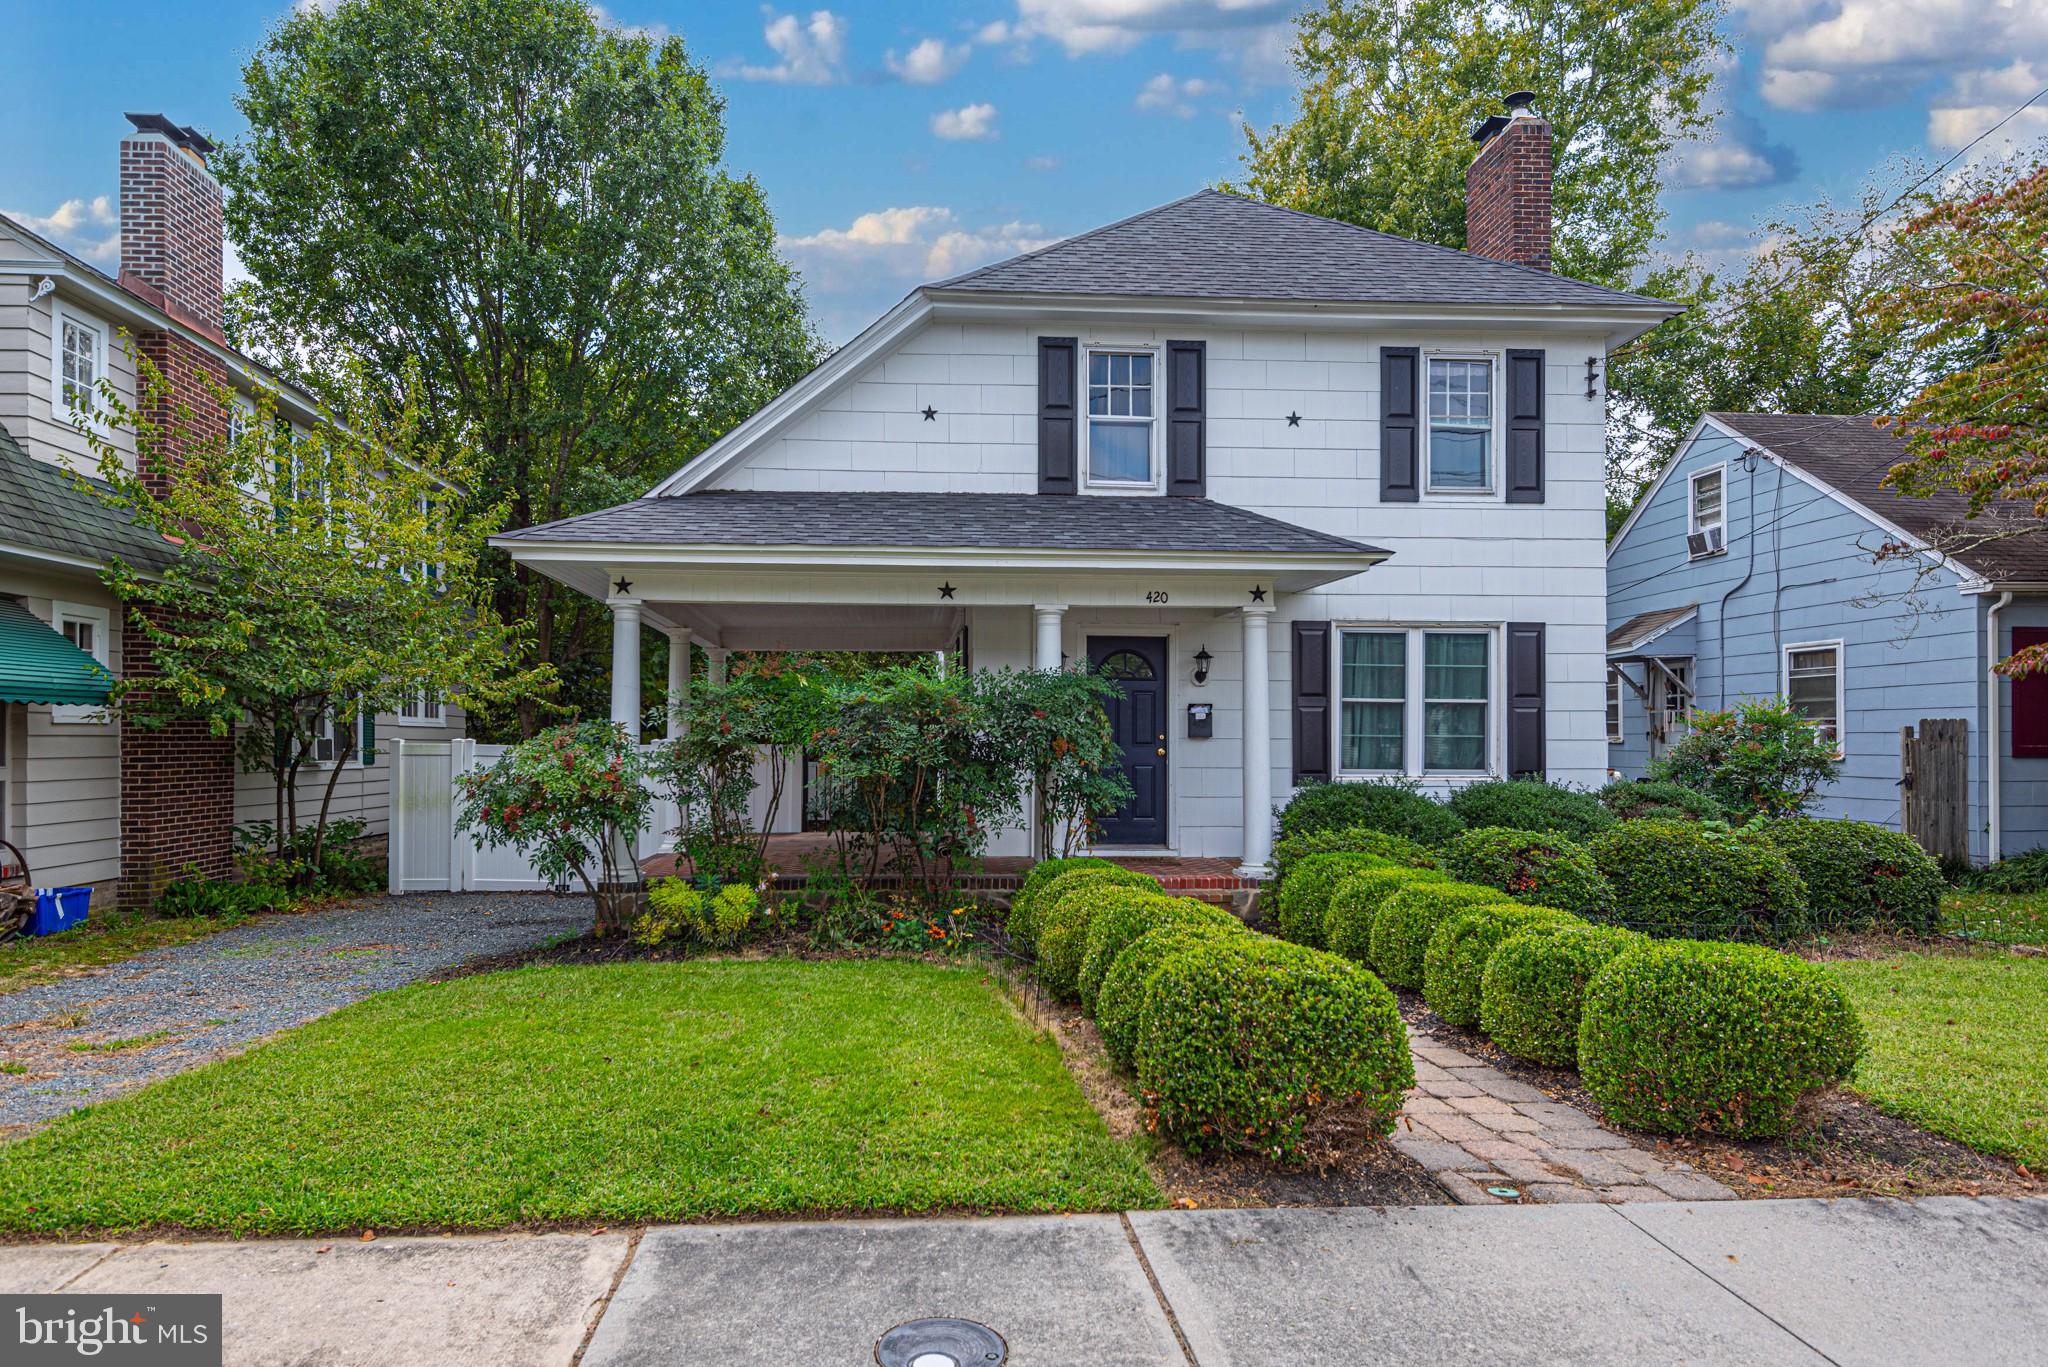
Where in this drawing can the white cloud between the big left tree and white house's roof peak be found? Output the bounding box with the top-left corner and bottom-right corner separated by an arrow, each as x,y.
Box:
780,205 -> 1059,293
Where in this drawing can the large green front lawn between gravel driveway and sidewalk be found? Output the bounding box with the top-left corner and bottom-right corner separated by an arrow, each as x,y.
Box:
0,959 -> 1161,1234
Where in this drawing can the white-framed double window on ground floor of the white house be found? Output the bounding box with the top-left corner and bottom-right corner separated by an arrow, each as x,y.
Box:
1337,625 -> 1499,777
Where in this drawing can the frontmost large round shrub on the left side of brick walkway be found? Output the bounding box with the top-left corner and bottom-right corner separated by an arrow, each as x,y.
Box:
1139,937 -> 1415,1160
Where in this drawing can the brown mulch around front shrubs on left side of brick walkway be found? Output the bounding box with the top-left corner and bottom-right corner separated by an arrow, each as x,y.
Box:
1008,974 -> 1450,1209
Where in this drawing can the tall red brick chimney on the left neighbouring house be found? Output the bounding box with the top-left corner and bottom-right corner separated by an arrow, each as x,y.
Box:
119,115 -> 236,904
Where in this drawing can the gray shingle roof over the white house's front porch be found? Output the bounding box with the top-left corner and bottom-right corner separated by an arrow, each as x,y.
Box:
496,490 -> 1386,555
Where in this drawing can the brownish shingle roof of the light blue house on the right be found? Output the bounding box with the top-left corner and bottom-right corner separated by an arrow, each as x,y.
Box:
1708,412 -> 2048,584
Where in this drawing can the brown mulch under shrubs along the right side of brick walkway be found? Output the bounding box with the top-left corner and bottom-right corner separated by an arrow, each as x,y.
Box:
1395,988 -> 2042,1197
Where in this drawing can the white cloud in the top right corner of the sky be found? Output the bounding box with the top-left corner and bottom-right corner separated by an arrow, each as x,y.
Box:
1737,0 -> 2048,113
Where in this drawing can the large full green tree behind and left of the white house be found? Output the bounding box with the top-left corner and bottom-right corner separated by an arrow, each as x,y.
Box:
217,0 -> 819,734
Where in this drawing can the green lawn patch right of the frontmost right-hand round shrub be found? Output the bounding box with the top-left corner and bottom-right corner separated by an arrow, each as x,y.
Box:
1827,953 -> 2048,1166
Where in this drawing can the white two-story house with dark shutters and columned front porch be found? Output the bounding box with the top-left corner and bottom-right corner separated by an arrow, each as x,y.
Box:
498,96 -> 1677,873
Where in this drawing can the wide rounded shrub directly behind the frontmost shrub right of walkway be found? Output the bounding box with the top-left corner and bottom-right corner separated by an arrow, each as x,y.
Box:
1587,822 -> 1806,941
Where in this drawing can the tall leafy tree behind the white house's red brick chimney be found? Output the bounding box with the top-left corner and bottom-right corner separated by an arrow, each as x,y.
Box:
1243,0 -> 1724,285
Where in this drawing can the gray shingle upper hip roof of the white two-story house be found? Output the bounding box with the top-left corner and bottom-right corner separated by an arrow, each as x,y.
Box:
926,191 -> 1679,314
